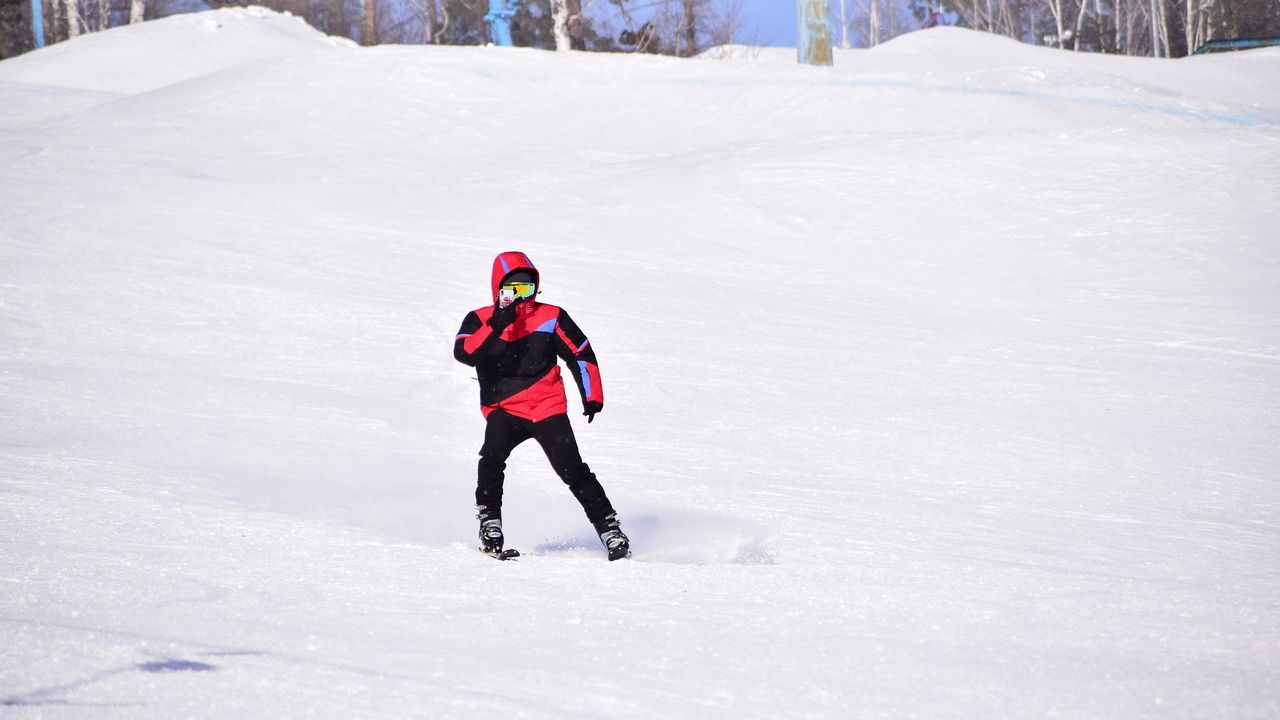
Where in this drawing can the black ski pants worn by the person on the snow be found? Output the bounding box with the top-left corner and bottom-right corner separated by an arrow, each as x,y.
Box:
476,410 -> 613,532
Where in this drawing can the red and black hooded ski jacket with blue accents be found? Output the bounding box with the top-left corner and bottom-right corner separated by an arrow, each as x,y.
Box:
453,252 -> 604,423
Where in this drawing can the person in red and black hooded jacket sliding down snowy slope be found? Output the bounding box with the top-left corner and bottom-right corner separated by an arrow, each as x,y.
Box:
453,252 -> 631,560
